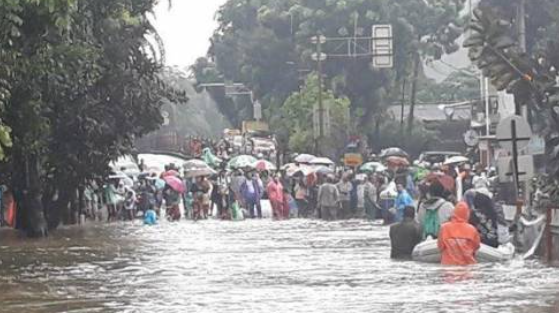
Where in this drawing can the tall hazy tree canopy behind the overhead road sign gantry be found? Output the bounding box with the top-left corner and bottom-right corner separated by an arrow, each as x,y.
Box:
195,0 -> 463,128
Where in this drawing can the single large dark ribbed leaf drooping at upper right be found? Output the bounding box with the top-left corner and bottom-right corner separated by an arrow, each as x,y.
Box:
463,9 -> 532,90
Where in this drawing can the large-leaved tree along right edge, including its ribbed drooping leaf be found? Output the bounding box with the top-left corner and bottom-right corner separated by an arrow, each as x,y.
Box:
464,6 -> 559,203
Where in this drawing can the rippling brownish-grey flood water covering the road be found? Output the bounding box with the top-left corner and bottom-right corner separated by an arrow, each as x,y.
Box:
0,220 -> 559,313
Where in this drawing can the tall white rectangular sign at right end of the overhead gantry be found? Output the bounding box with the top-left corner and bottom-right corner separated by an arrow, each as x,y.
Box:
372,25 -> 394,68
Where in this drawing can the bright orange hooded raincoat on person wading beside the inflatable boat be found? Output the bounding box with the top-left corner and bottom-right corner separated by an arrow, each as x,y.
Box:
438,202 -> 480,265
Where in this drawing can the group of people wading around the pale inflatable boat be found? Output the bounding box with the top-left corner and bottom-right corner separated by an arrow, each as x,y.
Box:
390,164 -> 513,265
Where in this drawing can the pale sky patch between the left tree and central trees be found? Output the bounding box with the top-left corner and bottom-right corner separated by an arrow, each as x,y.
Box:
155,0 -> 226,68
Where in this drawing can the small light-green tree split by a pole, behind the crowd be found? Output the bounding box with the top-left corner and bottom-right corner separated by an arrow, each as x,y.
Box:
269,75 -> 350,152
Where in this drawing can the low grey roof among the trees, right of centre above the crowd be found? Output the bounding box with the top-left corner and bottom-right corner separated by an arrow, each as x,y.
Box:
388,104 -> 472,122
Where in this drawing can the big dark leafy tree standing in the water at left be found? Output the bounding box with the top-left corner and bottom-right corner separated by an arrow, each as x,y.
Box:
2,0 -> 180,236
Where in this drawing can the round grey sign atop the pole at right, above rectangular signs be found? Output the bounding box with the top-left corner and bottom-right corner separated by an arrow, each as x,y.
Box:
497,115 -> 532,152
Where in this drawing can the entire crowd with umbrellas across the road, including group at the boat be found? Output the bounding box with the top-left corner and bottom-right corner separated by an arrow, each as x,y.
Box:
0,141 -> 510,264
